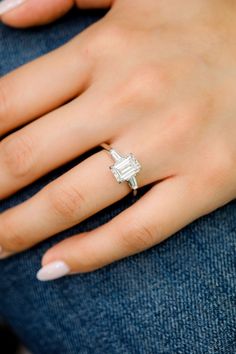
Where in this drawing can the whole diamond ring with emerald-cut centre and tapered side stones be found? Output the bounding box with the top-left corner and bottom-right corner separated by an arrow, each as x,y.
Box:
101,143 -> 141,195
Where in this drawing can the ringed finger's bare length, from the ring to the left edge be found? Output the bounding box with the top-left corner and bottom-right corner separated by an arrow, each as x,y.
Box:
0,150 -> 130,253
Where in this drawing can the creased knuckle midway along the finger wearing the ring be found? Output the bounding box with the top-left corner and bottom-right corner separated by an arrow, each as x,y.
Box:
48,183 -> 85,220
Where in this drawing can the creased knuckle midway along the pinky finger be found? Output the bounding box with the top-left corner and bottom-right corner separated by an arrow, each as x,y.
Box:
121,223 -> 157,252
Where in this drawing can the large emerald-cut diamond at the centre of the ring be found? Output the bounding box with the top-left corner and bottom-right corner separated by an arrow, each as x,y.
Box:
111,154 -> 141,183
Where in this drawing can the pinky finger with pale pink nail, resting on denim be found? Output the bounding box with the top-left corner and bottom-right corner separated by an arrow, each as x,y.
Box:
37,177 -> 204,281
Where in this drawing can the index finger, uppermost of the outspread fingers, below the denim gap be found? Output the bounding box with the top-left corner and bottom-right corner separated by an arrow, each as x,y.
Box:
0,36 -> 90,136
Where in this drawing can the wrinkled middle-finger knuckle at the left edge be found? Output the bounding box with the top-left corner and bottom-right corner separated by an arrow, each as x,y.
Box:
1,134 -> 34,178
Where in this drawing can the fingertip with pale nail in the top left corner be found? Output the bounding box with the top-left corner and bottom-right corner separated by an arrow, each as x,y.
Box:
0,0 -> 74,28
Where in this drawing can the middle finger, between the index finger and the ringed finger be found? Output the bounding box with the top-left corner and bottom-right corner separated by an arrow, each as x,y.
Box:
0,90 -> 112,200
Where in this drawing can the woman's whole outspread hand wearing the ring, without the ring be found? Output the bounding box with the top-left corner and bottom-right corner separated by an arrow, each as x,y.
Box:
0,0 -> 236,280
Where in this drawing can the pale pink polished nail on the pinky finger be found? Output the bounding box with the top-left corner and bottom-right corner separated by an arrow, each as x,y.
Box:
37,261 -> 70,281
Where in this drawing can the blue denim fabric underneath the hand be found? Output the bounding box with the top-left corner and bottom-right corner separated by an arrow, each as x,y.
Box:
0,7 -> 236,354
